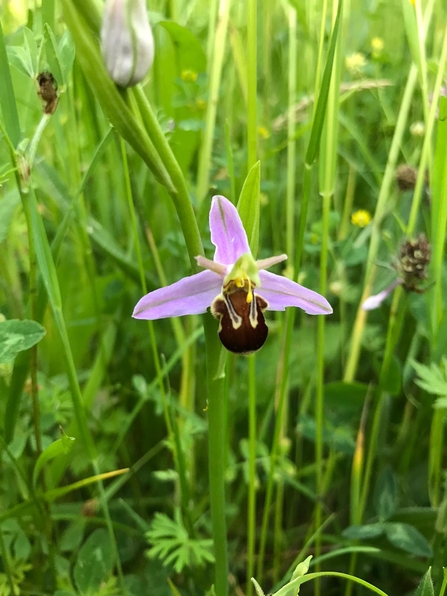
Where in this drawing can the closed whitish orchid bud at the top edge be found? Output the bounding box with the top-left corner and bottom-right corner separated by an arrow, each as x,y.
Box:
101,0 -> 154,87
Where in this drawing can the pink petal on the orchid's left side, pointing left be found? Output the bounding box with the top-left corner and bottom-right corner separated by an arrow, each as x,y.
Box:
132,271 -> 222,320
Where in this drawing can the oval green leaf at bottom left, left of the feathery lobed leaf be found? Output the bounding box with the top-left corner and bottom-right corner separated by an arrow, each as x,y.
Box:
74,530 -> 113,596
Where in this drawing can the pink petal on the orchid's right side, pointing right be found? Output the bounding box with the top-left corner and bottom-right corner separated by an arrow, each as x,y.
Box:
256,271 -> 332,315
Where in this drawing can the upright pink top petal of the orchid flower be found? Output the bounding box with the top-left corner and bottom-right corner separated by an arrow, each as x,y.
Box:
210,195 -> 250,265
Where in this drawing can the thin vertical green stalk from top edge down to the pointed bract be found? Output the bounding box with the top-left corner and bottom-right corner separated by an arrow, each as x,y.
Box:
246,0 -> 258,170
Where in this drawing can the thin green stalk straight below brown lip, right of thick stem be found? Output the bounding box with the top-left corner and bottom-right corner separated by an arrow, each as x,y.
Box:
246,354 -> 257,596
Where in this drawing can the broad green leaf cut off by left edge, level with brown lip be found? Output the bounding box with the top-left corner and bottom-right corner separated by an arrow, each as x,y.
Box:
0,319 -> 46,364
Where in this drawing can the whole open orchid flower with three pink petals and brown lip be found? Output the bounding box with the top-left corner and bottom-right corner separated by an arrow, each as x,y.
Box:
132,196 -> 332,354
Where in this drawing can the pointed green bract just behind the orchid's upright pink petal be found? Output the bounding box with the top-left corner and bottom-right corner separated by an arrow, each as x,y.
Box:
237,161 -> 261,256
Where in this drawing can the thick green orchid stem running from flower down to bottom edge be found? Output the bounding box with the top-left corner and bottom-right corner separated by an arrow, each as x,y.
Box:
203,314 -> 228,596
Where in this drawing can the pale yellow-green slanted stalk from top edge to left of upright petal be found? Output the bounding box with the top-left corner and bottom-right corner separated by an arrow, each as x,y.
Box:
197,0 -> 231,204
